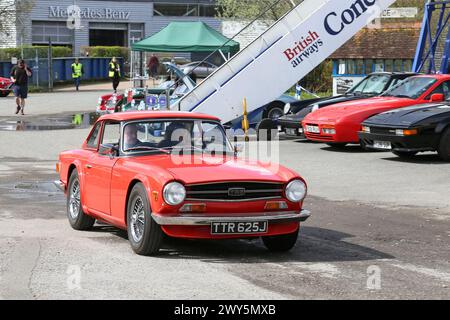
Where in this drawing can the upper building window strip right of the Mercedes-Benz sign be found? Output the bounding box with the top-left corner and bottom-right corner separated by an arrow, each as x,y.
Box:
153,3 -> 216,17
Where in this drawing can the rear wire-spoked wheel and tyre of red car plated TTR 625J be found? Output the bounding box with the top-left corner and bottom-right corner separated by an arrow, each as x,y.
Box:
67,170 -> 95,231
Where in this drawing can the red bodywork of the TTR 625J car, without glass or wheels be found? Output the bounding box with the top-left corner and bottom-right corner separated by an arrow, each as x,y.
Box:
59,111 -> 303,239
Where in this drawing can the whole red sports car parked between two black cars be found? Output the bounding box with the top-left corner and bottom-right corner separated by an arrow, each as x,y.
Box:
302,75 -> 450,147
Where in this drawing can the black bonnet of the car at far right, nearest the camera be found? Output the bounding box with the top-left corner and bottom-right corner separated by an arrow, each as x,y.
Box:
364,103 -> 450,127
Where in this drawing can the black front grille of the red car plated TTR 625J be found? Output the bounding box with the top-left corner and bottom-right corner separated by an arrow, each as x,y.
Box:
186,181 -> 284,201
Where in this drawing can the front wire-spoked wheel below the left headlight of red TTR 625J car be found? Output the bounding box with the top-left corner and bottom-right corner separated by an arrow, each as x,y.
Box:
127,183 -> 163,256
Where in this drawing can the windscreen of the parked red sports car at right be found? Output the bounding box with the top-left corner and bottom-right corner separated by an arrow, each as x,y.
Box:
383,77 -> 437,99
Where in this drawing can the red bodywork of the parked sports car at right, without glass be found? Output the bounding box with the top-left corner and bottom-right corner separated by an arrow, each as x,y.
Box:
302,75 -> 450,143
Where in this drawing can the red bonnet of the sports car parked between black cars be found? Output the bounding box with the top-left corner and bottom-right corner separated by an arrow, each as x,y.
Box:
305,97 -> 416,121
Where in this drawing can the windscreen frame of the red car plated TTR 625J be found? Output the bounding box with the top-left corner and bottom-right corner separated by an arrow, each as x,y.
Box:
119,118 -> 234,156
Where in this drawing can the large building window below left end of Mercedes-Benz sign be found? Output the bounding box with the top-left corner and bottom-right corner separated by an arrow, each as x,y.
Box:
32,21 -> 73,45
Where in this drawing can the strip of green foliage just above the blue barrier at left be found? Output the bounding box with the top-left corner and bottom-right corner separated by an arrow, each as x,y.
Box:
0,46 -> 72,61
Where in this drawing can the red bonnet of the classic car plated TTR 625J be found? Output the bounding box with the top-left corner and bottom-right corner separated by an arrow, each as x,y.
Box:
125,154 -> 298,184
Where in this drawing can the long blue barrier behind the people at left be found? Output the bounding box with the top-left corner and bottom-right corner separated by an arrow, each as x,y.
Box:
0,58 -> 124,86
